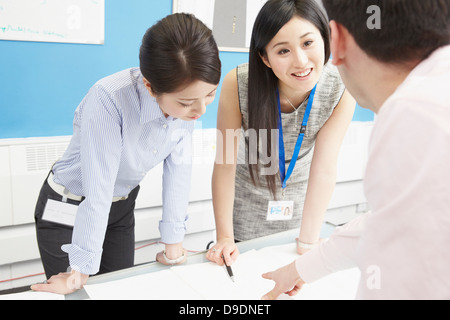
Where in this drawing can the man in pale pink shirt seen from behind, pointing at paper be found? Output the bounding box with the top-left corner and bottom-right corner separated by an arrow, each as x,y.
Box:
263,0 -> 450,299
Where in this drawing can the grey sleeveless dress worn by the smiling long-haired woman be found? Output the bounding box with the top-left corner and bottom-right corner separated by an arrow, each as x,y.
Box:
233,62 -> 345,241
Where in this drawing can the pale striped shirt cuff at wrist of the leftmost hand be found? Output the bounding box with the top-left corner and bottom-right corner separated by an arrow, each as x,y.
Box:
61,244 -> 103,275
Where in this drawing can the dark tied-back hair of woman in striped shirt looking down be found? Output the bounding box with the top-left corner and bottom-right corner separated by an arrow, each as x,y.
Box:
139,13 -> 221,95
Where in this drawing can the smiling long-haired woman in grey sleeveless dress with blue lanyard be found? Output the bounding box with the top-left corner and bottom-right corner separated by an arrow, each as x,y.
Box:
206,0 -> 355,265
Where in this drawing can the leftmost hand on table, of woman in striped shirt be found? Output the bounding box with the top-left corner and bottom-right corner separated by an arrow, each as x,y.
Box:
31,270 -> 89,294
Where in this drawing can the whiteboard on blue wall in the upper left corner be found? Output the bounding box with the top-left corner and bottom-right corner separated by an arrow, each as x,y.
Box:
0,0 -> 105,44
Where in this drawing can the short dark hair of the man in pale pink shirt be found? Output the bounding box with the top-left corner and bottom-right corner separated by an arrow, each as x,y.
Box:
322,0 -> 450,65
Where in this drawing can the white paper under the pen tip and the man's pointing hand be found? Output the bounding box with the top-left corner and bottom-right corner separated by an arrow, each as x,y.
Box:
172,244 -> 359,300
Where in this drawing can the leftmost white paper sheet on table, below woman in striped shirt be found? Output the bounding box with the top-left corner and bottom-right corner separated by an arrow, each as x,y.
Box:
84,269 -> 201,300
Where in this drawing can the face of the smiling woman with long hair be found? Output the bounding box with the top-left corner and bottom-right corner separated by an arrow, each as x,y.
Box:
261,16 -> 325,92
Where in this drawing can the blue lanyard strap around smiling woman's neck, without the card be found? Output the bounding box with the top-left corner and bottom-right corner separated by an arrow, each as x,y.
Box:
277,84 -> 317,191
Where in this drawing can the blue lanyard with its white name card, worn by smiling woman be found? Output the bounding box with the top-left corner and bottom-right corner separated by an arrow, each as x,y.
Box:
267,84 -> 317,220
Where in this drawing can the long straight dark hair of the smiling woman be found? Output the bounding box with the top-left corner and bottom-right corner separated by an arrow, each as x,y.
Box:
248,0 -> 330,196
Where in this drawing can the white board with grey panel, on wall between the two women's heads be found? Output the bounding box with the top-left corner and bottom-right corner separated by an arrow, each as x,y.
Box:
173,0 -> 267,52
